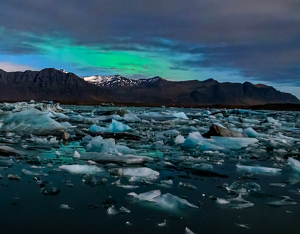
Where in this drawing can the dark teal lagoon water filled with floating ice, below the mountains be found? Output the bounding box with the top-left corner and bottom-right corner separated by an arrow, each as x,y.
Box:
0,103 -> 300,233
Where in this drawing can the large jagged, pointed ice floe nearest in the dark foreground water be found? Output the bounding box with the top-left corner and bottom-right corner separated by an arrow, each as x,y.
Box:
128,190 -> 199,210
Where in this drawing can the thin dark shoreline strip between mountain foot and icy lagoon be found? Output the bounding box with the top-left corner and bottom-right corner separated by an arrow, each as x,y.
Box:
0,100 -> 300,111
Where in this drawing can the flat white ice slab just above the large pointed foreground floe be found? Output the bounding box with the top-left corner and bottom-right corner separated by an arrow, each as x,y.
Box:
108,167 -> 159,180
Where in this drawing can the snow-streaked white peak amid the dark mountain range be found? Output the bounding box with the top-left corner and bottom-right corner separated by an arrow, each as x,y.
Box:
83,75 -> 162,88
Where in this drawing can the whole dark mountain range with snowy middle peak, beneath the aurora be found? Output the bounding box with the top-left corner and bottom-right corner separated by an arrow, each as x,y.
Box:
0,68 -> 300,107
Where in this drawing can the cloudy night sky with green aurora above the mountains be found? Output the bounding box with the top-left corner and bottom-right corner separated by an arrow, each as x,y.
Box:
0,0 -> 300,97
